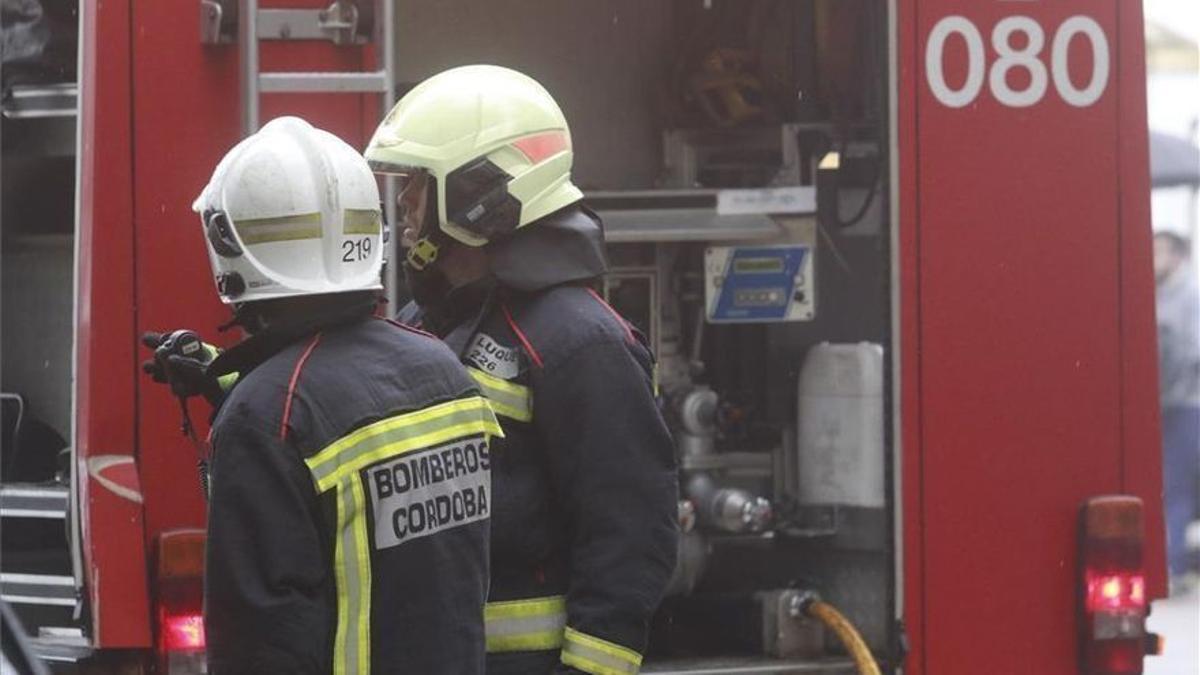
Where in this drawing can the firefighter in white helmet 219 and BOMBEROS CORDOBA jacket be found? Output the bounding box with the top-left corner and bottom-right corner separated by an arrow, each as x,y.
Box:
144,118 -> 500,675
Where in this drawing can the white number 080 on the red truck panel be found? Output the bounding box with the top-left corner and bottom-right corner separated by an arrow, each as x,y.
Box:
925,16 -> 1109,108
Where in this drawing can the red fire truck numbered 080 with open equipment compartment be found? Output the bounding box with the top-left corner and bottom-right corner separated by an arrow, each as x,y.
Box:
0,0 -> 1165,675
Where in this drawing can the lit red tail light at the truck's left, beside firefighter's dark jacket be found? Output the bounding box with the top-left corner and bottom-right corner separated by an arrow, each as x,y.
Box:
155,530 -> 206,675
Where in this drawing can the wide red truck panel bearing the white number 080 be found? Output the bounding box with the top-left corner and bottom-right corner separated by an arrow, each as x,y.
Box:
899,0 -> 1162,674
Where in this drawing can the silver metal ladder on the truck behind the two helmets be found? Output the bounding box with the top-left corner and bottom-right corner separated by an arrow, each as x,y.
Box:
200,0 -> 397,306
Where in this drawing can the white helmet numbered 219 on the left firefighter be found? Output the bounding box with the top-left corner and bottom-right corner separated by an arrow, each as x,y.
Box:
192,117 -> 383,304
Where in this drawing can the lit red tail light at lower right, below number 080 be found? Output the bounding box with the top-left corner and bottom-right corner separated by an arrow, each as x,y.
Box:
1079,495 -> 1152,675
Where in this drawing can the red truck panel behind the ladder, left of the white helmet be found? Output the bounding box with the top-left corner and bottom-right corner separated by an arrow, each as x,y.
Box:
132,0 -> 377,540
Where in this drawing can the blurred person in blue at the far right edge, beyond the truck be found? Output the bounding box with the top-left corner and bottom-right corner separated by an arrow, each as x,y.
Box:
1154,232 -> 1200,592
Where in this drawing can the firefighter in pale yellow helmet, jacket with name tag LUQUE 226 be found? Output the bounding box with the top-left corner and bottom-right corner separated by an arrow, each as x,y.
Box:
366,66 -> 677,674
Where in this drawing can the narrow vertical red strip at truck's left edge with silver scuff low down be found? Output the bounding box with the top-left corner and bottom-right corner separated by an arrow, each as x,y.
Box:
74,1 -> 151,647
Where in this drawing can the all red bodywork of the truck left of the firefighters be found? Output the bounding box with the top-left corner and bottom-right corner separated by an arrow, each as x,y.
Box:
76,0 -> 378,647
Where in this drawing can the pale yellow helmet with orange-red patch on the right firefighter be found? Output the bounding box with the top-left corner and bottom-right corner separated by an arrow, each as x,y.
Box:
365,65 -> 583,263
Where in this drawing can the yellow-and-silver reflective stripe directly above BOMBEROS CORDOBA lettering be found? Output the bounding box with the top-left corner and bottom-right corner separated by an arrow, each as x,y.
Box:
305,396 -> 504,492
